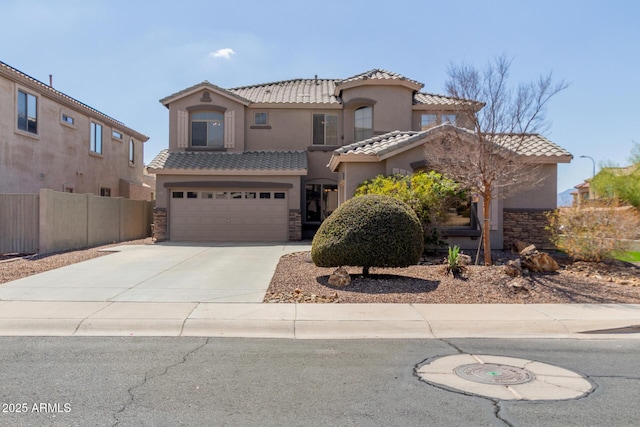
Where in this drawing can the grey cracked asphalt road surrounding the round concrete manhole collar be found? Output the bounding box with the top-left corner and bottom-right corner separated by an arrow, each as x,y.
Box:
0,337 -> 640,427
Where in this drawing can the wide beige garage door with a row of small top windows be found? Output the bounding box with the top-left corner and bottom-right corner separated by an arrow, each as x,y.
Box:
169,190 -> 289,242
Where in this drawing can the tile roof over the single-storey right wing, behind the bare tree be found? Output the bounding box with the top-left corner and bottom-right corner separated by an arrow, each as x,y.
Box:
334,124 -> 571,162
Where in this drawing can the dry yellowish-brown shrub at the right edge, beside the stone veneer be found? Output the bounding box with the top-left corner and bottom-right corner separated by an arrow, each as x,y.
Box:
547,202 -> 640,262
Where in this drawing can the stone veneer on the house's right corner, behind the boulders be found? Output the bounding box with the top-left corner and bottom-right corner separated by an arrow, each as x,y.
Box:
503,209 -> 555,250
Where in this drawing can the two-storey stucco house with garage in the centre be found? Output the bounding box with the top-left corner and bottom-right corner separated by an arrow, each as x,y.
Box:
148,70 -> 571,248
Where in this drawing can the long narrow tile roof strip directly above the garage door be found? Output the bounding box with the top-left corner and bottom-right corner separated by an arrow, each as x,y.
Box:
148,149 -> 307,171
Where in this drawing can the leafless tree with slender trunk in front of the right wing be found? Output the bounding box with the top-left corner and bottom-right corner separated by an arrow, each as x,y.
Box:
425,55 -> 567,265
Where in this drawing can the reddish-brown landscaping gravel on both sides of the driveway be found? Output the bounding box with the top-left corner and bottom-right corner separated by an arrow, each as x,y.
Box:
0,239 -> 640,304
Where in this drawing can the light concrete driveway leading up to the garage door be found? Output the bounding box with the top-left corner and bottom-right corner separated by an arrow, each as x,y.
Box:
0,242 -> 311,302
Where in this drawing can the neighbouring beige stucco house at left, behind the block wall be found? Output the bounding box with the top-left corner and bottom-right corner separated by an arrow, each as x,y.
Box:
0,62 -> 152,200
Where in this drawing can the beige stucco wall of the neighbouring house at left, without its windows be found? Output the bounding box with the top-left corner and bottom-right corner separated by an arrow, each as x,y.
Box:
0,75 -> 144,196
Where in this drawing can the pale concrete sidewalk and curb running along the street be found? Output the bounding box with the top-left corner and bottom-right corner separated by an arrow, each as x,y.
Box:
0,301 -> 640,339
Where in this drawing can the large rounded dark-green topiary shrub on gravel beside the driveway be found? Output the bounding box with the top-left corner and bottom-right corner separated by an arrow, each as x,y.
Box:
311,194 -> 423,275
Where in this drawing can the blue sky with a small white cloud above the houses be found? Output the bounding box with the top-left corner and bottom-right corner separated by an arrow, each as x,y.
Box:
0,0 -> 640,192
